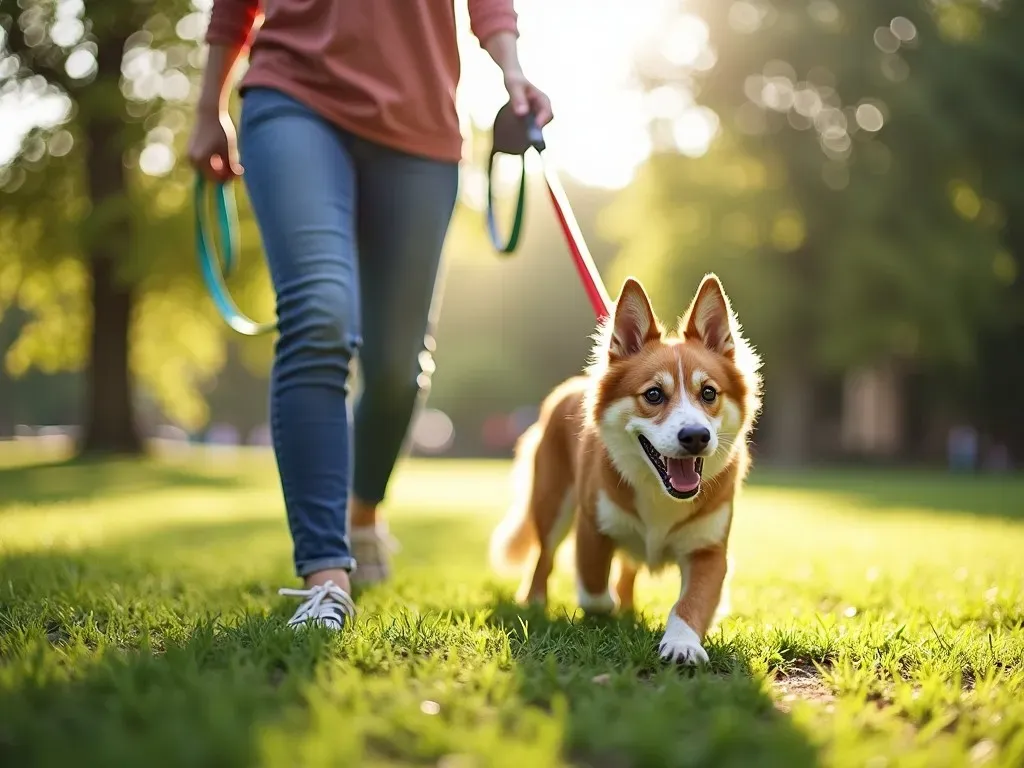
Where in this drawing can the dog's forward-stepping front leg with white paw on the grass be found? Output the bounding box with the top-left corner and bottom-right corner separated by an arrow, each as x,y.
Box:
658,547 -> 727,665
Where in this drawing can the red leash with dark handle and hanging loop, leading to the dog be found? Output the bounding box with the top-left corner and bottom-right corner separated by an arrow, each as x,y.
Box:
487,104 -> 611,321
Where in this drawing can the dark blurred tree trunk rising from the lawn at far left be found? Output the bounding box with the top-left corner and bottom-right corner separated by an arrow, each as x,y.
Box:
81,31 -> 143,455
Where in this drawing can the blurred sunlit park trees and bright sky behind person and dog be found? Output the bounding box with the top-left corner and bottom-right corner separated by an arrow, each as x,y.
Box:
0,0 -> 1024,472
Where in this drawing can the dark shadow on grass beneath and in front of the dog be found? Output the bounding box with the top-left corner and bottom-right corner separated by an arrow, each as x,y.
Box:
479,599 -> 818,768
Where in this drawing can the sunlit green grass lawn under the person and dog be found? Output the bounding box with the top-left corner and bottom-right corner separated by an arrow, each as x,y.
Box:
0,448 -> 1024,768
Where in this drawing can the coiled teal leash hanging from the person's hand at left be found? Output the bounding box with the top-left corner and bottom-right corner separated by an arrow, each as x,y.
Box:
195,178 -> 278,336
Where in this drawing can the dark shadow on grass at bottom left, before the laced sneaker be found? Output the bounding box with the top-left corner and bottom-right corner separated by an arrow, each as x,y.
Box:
0,602 -> 338,768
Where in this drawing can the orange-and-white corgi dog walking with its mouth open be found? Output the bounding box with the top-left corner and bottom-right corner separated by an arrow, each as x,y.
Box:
489,274 -> 761,665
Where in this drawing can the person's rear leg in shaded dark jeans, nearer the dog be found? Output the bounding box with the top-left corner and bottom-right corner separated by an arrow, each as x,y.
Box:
351,141 -> 459,583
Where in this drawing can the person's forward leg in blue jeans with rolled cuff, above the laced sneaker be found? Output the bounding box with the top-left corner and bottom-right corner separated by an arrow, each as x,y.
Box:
240,82 -> 359,614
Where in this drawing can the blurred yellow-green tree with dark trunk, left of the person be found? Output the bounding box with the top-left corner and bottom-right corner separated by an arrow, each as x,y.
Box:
0,0 -> 271,453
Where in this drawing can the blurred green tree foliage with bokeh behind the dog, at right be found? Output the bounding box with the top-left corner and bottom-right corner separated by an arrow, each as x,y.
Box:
607,0 -> 1024,456
